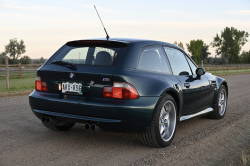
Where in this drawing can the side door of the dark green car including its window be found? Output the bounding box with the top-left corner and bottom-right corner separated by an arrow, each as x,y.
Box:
164,47 -> 211,115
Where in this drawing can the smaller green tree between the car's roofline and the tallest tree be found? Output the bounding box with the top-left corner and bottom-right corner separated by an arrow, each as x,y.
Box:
186,39 -> 211,63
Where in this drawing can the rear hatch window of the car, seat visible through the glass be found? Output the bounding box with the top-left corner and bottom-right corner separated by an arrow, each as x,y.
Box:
48,41 -> 127,67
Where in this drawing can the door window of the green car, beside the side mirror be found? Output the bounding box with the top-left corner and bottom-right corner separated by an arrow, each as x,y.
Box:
164,47 -> 192,75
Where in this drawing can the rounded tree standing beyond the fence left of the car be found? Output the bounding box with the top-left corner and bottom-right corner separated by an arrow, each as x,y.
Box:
5,38 -> 26,63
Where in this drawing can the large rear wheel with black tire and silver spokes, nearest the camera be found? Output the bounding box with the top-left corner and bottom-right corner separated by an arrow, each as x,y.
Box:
140,94 -> 177,148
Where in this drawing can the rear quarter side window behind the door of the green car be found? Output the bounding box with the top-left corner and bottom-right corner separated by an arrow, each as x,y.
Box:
137,46 -> 172,74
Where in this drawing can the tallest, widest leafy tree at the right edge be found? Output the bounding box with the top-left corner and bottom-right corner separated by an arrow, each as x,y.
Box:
211,27 -> 249,63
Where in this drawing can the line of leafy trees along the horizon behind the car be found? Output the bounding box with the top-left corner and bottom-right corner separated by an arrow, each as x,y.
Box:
0,27 -> 250,64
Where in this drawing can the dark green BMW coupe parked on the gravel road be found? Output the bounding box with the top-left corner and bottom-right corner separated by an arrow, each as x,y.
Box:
29,38 -> 228,147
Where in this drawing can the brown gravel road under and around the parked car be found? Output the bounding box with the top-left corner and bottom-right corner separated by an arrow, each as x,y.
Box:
0,74 -> 250,166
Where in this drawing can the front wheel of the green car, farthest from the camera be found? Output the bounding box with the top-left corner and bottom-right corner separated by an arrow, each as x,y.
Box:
208,85 -> 227,119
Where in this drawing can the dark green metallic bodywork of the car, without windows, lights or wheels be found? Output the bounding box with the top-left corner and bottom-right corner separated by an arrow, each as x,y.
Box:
29,39 -> 227,130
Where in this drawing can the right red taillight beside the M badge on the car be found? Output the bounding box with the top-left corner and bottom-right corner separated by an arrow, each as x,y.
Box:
102,82 -> 139,99
